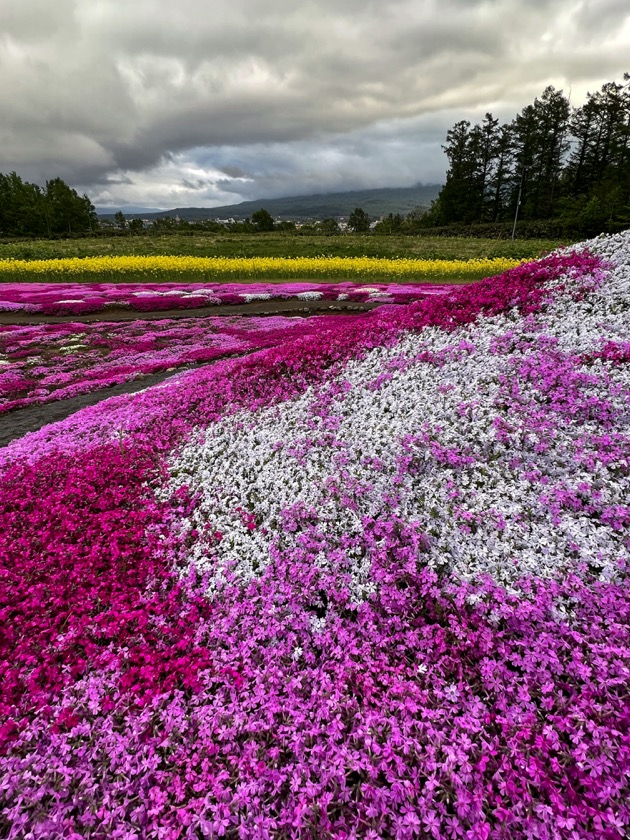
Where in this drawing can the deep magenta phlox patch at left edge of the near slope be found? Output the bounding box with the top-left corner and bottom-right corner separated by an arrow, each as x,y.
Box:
0,444 -> 215,716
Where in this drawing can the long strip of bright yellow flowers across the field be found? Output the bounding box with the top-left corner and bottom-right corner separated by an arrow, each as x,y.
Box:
0,256 -> 525,282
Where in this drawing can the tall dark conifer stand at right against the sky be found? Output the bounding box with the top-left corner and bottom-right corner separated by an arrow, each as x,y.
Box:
422,73 -> 630,235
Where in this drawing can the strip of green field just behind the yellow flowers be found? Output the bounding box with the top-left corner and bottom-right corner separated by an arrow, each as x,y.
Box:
0,233 -> 569,260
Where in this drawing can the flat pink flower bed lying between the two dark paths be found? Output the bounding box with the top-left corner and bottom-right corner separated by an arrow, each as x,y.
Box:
0,315 -> 356,414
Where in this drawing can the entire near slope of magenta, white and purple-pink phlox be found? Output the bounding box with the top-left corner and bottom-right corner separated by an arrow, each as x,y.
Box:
0,234 -> 630,840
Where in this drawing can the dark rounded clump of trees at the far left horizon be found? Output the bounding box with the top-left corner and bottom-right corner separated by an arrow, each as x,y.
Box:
0,172 -> 98,236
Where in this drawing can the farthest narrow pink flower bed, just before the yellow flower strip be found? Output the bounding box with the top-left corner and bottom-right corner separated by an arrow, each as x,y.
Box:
0,282 -> 450,315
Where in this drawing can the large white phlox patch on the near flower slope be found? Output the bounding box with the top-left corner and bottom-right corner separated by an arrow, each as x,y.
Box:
167,230 -> 630,600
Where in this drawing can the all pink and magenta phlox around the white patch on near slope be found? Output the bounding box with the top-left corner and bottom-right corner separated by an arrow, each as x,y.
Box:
0,246 -> 630,840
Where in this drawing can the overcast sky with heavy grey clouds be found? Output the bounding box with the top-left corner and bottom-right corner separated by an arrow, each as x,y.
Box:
0,0 -> 630,208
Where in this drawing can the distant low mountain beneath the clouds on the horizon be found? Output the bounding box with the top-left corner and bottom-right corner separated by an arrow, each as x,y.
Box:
99,184 -> 441,221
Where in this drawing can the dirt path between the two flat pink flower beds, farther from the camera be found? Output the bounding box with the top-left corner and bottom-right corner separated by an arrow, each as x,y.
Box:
0,298 -> 383,325
